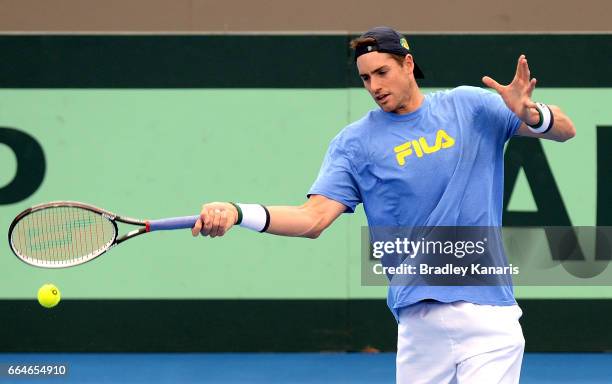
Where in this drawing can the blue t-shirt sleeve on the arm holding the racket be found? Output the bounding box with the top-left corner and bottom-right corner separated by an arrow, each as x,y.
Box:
307,137 -> 361,213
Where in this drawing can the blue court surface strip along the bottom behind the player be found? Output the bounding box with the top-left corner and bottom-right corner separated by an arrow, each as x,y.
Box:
0,353 -> 612,384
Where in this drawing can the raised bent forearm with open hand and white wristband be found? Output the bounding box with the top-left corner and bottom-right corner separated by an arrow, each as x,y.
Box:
482,55 -> 576,141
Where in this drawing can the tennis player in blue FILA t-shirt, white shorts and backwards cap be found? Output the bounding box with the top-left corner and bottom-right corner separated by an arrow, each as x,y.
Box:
192,27 -> 575,384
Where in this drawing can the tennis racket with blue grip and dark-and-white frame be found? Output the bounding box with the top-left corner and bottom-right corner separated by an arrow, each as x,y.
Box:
8,201 -> 199,268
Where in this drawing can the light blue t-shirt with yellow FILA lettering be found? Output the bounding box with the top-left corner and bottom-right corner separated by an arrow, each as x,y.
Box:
308,86 -> 521,318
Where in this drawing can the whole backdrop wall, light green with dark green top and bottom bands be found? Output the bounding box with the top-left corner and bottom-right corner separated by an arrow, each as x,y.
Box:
0,34 -> 612,352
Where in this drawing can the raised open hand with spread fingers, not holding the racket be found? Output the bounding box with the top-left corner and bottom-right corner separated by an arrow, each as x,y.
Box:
482,55 -> 539,125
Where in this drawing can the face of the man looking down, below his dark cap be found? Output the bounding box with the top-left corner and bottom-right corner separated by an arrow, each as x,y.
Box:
357,51 -> 414,113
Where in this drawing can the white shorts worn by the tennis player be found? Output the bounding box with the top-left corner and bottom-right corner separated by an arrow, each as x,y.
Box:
396,301 -> 525,384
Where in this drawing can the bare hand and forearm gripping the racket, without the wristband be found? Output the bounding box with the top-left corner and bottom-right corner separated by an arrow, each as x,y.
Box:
192,195 -> 346,239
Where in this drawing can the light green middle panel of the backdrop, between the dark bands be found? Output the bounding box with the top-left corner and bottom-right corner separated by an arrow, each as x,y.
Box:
0,88 -> 612,299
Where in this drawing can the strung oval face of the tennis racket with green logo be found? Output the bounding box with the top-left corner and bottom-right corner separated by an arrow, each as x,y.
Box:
11,207 -> 116,265
